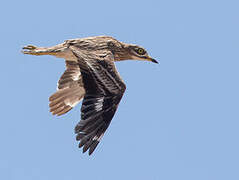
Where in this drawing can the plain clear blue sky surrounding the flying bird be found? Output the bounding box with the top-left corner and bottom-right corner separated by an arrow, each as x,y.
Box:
0,0 -> 239,180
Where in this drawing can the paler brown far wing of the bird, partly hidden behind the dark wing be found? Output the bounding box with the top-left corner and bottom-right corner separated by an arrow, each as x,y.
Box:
49,60 -> 85,116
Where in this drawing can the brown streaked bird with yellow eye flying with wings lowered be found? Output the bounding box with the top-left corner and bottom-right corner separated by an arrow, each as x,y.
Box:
22,36 -> 158,155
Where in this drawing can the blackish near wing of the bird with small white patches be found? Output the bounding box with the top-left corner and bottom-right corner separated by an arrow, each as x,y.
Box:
70,46 -> 126,155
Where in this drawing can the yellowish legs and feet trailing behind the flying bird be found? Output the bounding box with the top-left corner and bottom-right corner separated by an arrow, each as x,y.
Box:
22,45 -> 62,56
